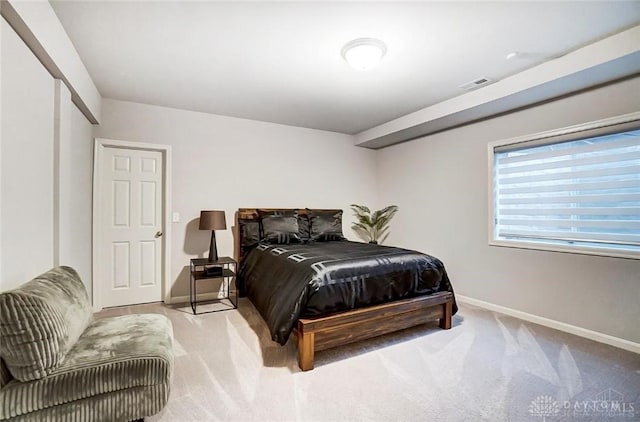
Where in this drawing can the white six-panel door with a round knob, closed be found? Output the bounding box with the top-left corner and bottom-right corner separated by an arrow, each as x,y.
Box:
98,147 -> 164,307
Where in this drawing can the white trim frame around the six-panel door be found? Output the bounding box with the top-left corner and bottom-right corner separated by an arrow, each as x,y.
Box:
91,138 -> 171,312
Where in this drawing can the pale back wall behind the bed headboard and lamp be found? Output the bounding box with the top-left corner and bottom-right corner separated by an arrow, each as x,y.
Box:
94,99 -> 376,297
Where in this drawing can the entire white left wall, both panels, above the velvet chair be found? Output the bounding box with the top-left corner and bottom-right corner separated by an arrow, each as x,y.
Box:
0,18 -> 92,292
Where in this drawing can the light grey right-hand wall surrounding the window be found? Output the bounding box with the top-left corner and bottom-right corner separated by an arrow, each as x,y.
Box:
377,77 -> 640,342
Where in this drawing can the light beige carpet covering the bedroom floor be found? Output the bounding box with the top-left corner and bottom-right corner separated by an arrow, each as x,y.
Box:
101,299 -> 640,422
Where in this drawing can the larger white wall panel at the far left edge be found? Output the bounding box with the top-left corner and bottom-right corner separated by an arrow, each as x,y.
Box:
0,19 -> 54,290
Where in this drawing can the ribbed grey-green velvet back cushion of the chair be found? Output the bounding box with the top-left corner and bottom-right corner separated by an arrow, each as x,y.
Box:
0,267 -> 93,381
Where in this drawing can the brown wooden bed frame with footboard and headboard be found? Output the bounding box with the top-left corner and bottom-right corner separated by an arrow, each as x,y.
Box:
234,208 -> 453,371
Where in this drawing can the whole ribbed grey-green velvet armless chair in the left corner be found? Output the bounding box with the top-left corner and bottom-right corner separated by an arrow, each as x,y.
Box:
0,267 -> 173,422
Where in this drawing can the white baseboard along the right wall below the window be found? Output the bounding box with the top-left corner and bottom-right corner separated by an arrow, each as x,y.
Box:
456,294 -> 640,354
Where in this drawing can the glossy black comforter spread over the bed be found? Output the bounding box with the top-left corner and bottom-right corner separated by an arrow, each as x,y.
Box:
238,241 -> 457,344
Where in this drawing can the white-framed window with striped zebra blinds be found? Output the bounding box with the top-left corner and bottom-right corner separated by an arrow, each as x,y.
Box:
489,113 -> 640,259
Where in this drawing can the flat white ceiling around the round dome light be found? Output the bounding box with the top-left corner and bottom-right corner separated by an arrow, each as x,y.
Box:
51,0 -> 640,134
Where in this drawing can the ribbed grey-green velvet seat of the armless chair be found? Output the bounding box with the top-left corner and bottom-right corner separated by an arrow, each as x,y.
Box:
0,314 -> 173,420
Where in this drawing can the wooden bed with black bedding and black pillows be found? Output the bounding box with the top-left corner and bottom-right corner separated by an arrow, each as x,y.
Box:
235,208 -> 457,371
